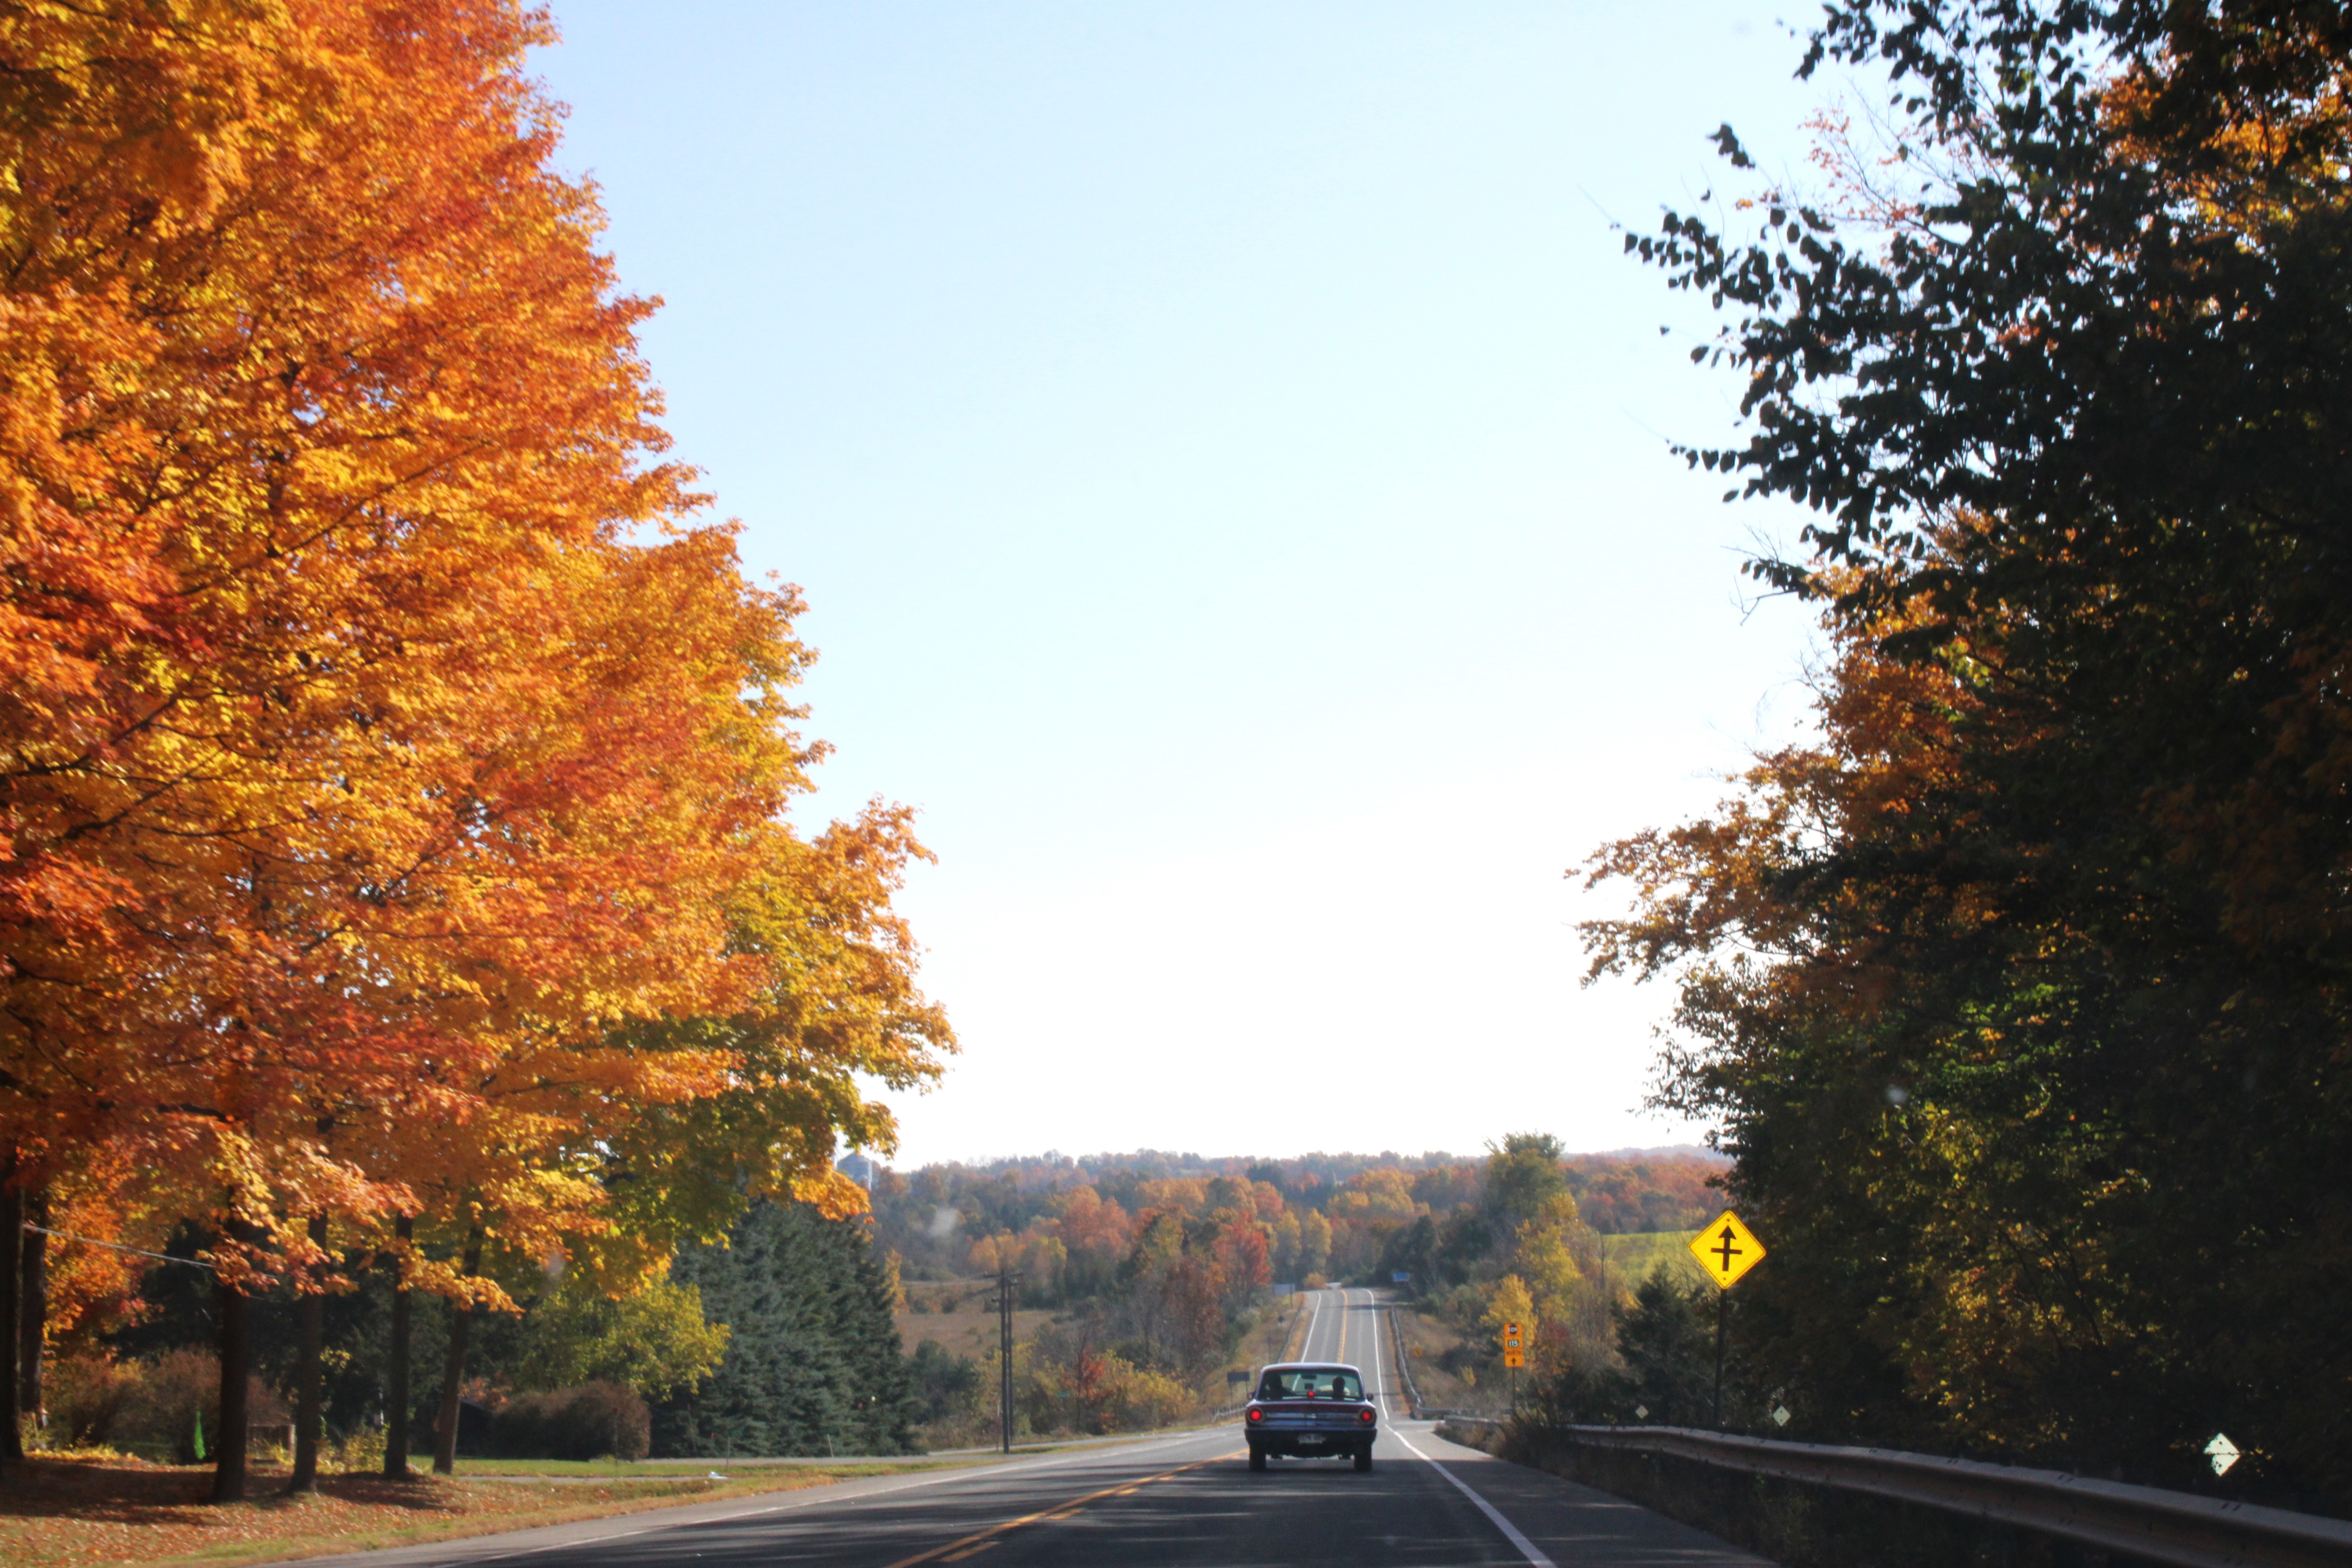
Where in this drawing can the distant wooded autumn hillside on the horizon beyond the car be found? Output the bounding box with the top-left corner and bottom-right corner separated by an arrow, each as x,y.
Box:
861,1133 -> 1724,1441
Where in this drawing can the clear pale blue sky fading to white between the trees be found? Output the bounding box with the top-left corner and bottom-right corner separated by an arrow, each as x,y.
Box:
536,0 -> 1835,1166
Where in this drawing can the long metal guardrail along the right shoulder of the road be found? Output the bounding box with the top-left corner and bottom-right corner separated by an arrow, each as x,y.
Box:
1543,1422 -> 2352,1568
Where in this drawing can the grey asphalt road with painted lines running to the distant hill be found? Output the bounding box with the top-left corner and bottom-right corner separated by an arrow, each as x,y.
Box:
299,1290 -> 1762,1568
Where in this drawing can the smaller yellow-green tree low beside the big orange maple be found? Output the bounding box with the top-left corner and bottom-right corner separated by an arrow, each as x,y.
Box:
402,804 -> 955,1472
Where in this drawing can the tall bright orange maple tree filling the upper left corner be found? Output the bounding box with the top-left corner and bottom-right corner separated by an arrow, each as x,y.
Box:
0,0 -> 946,1497
